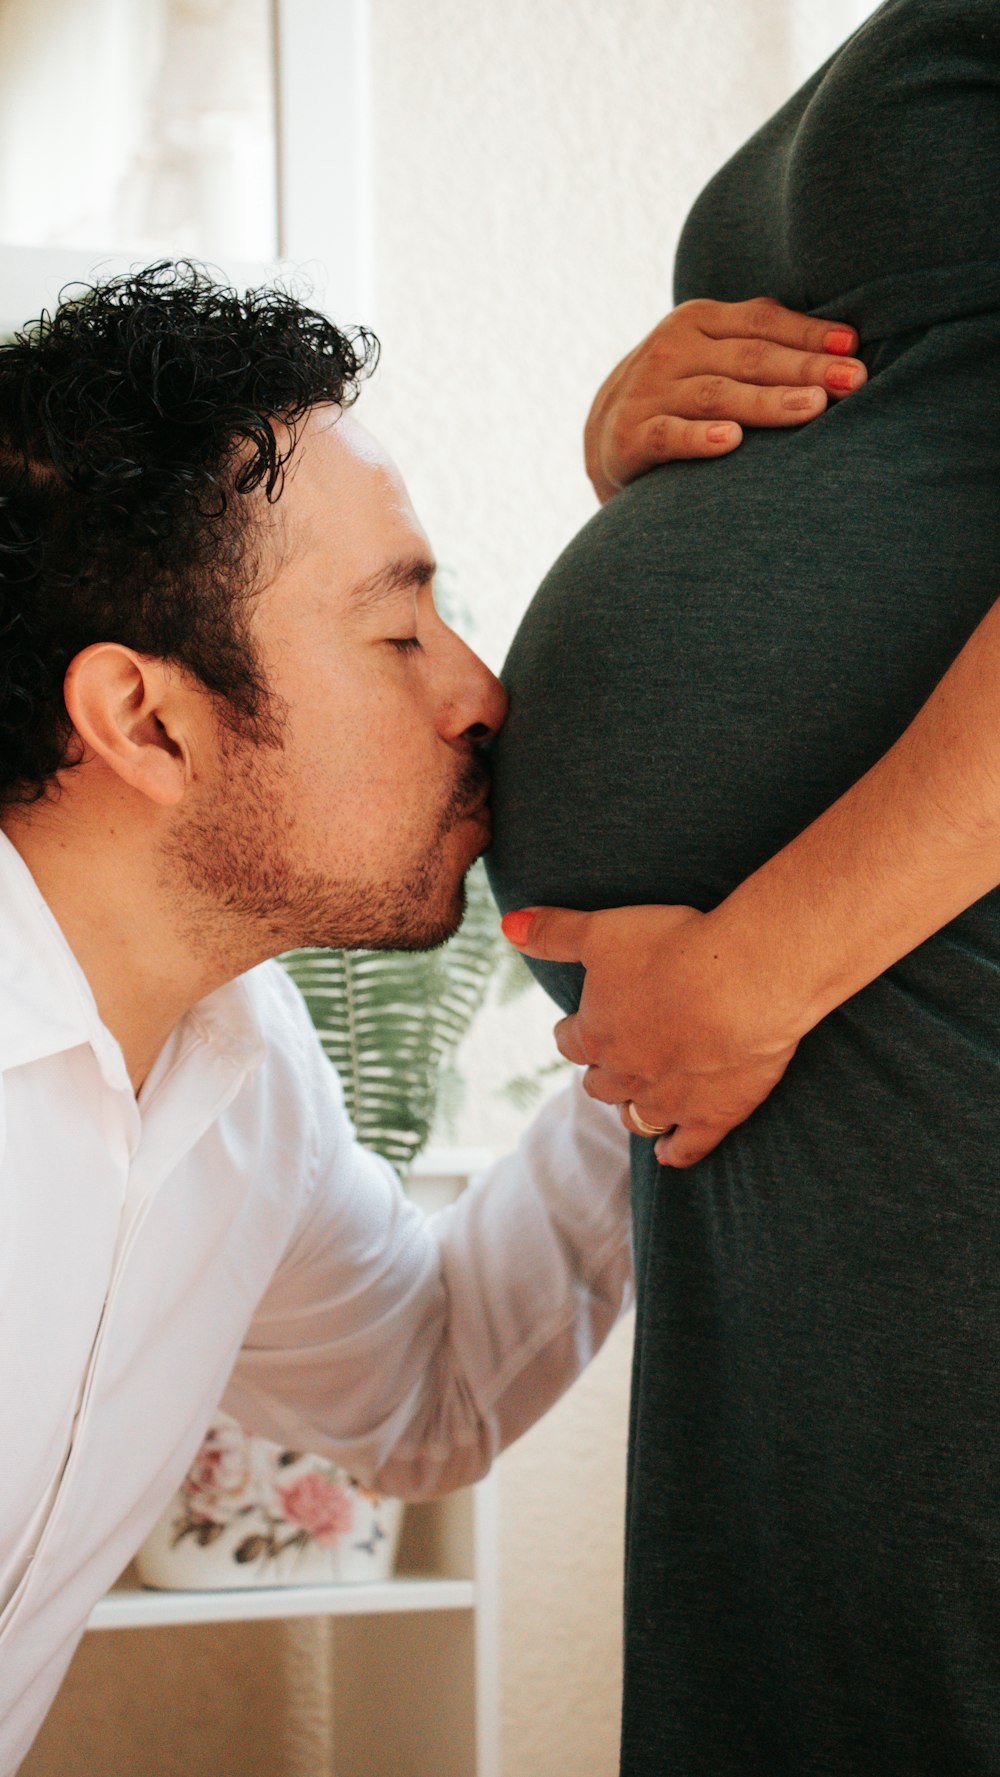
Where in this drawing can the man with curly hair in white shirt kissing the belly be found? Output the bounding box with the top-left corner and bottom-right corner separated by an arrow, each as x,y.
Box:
0,265 -> 859,1773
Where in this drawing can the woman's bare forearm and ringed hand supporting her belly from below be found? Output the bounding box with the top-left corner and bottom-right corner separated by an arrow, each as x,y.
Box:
504,604 -> 1000,1166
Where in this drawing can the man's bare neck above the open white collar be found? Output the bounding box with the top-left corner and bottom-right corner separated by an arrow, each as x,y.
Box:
0,796 -> 239,1093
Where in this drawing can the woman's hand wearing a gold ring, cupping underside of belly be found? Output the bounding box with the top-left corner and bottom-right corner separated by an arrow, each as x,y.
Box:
503,906 -> 810,1166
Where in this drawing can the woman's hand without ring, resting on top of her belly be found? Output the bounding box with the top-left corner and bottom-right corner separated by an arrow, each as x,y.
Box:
584,297 -> 867,501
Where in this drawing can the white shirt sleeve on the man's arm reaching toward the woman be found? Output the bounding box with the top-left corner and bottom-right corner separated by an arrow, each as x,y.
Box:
222,1051 -> 632,1498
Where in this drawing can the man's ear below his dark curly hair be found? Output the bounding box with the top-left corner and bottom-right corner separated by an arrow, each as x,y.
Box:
64,641 -> 194,809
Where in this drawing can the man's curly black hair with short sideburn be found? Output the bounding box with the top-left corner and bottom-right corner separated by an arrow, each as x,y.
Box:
0,261 -> 378,807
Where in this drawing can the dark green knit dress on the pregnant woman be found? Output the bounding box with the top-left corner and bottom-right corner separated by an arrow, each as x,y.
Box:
488,0 -> 1000,1777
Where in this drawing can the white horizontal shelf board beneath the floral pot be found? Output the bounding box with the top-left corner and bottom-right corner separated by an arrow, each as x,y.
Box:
87,1573 -> 476,1630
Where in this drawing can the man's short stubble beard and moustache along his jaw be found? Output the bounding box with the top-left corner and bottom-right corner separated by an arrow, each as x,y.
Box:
165,725 -> 487,972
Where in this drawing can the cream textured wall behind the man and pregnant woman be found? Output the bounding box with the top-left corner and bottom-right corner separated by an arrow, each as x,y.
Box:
15,0 -> 870,1777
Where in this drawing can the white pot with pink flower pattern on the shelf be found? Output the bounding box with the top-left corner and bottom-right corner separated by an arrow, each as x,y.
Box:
135,1413 -> 403,1590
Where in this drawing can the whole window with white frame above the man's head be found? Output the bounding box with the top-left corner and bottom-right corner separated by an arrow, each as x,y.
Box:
0,0 -> 369,329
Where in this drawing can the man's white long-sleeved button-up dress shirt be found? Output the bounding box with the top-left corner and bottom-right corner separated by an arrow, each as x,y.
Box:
0,835 -> 632,1777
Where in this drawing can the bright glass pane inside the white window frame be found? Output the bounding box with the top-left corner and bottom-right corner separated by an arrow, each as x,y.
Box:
0,0 -> 277,261
